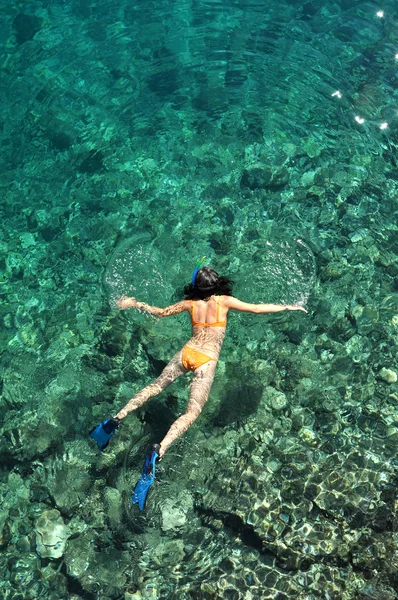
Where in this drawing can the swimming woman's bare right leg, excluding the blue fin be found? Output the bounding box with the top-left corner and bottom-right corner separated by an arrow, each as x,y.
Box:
159,360 -> 217,457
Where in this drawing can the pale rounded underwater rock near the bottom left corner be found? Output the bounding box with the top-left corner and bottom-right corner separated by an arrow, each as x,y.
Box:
36,509 -> 70,558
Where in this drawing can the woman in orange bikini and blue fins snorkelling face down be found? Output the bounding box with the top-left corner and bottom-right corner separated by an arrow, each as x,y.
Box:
90,264 -> 307,510
